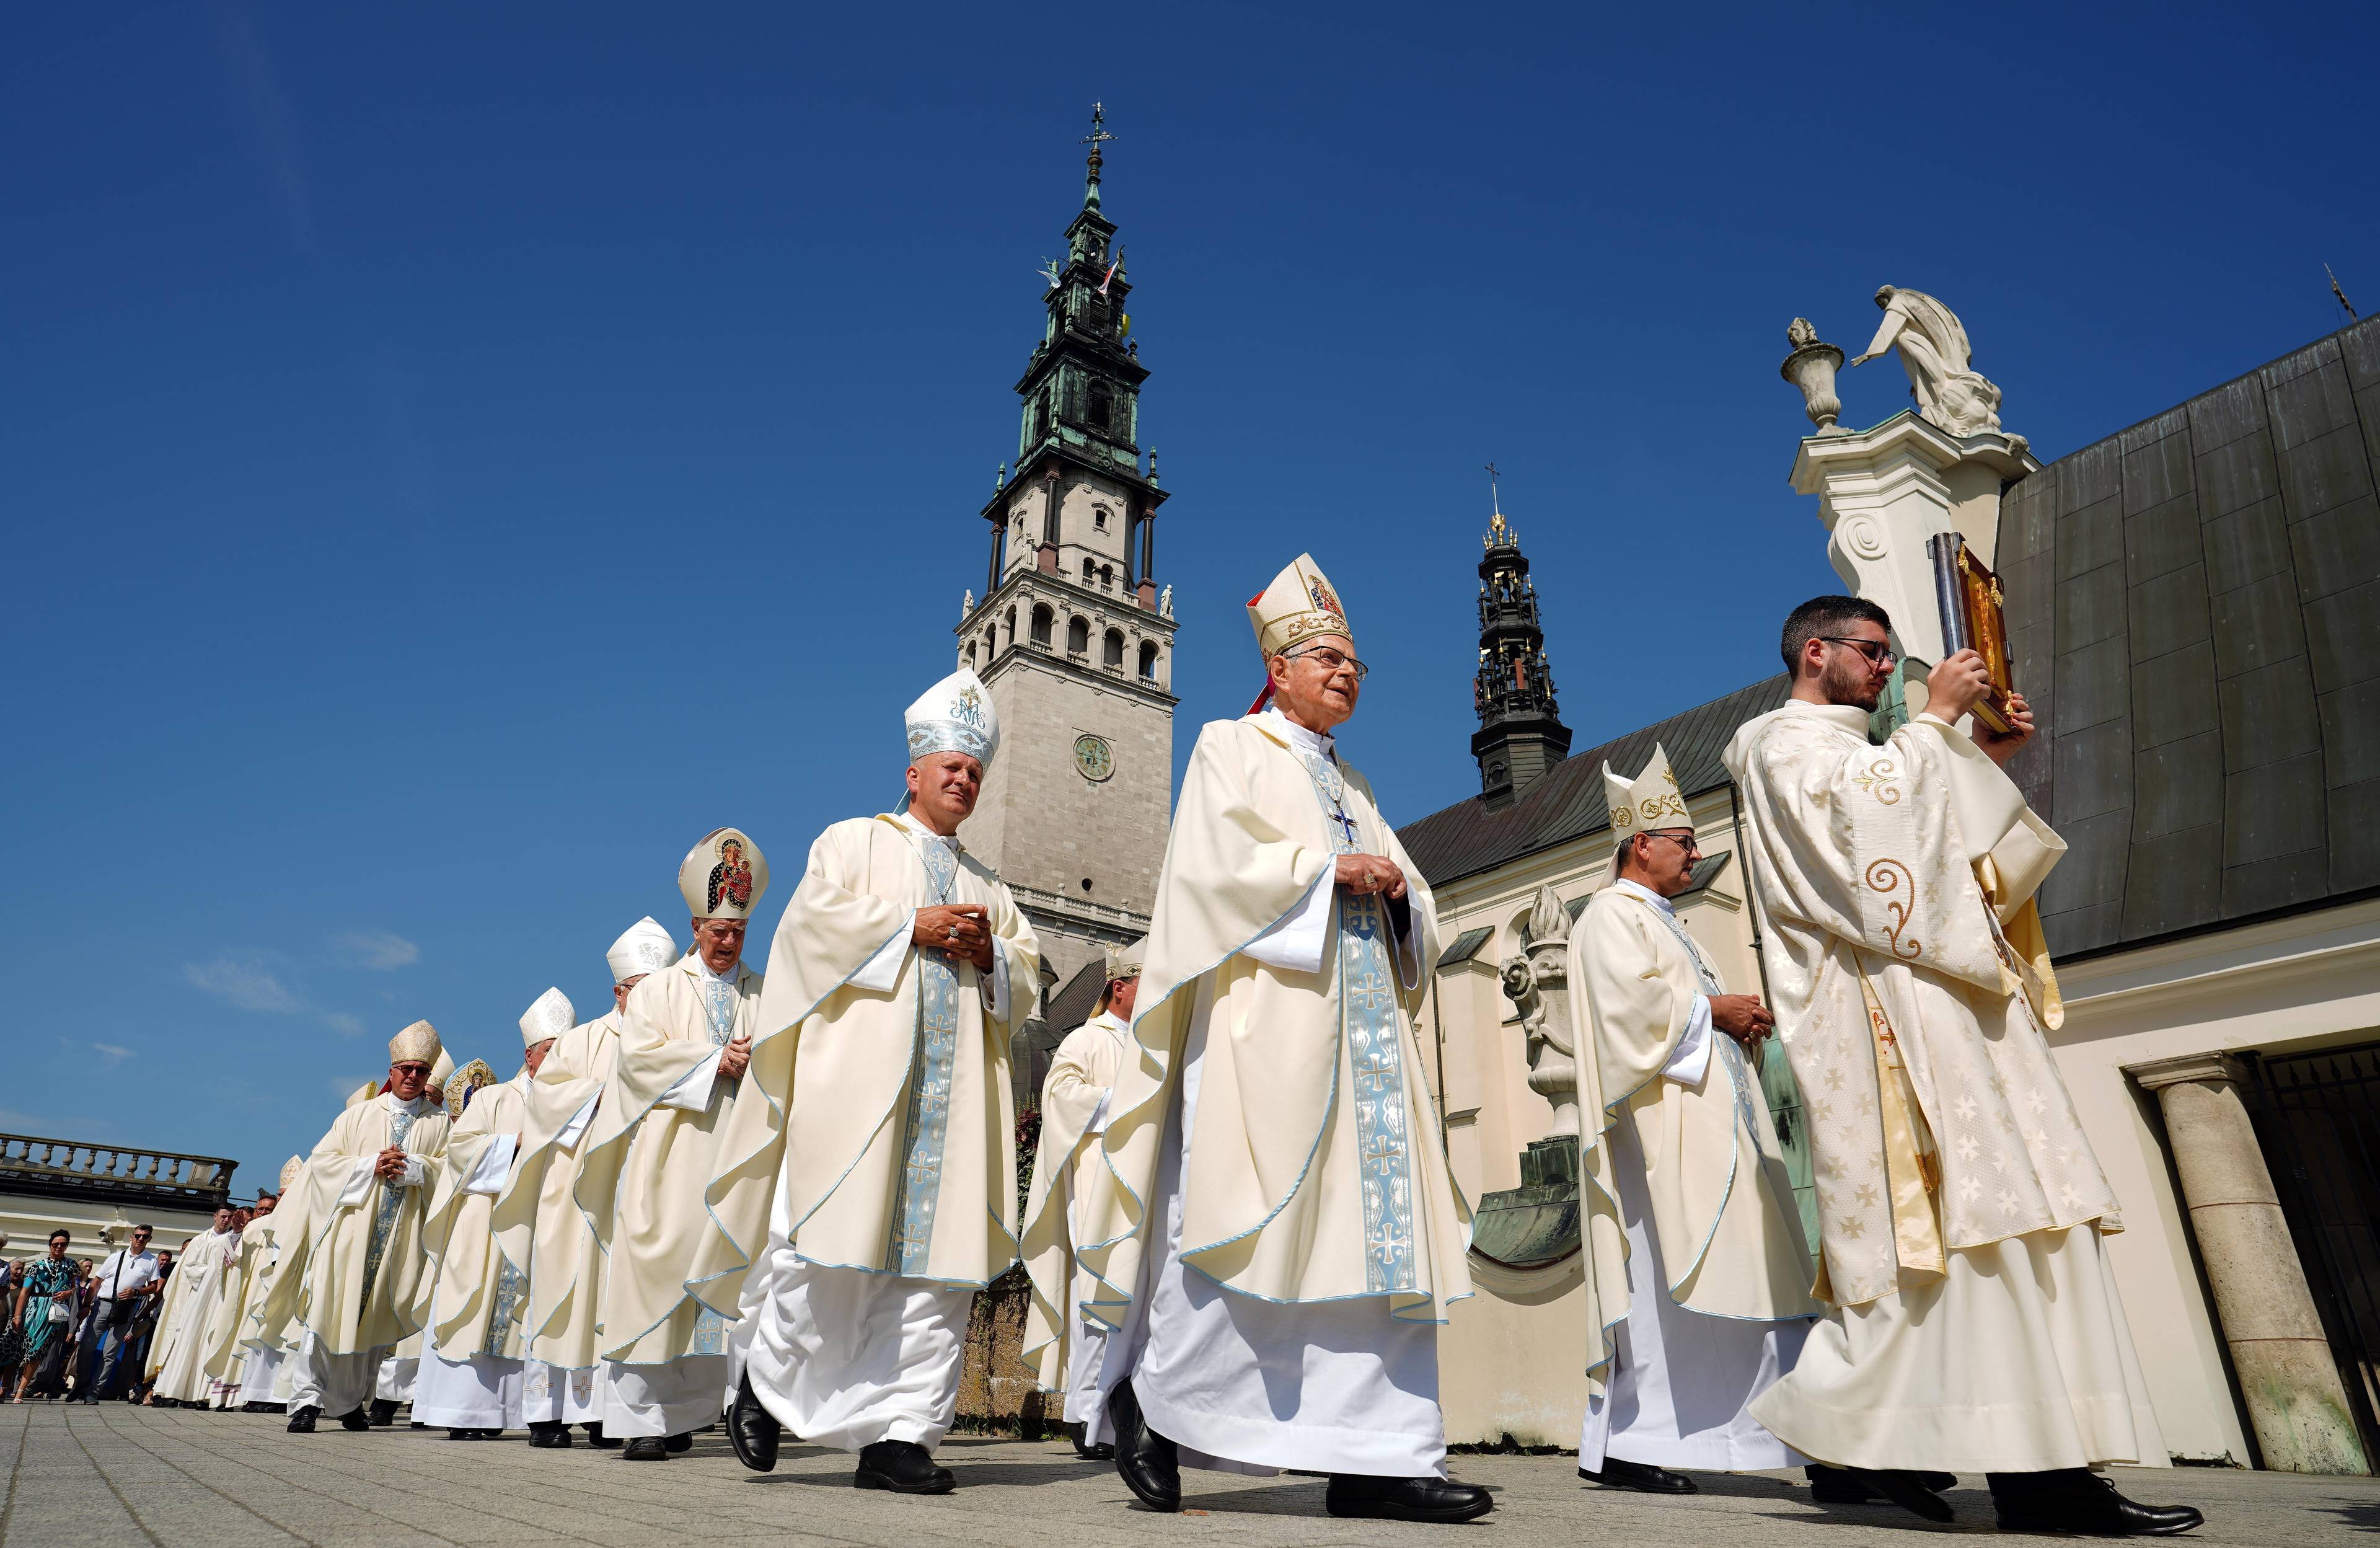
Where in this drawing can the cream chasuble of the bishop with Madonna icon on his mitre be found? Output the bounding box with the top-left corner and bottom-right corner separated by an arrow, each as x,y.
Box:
573,953 -> 766,1364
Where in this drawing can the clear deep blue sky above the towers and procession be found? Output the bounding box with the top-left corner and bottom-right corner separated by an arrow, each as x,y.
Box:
0,2 -> 2380,1191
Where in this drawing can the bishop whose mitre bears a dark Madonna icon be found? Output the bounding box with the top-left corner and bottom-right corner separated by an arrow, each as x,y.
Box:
576,829 -> 769,1462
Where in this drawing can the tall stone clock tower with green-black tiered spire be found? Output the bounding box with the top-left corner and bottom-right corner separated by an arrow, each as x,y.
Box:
957,107 -> 1176,984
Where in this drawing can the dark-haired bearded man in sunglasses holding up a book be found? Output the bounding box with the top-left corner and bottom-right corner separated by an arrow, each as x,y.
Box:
1726,598 -> 2199,1534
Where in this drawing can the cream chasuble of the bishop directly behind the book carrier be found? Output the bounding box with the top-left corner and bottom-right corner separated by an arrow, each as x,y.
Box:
1569,881 -> 1821,1395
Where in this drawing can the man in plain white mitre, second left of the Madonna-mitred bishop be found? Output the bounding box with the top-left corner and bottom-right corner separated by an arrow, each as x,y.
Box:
414,988 -> 578,1441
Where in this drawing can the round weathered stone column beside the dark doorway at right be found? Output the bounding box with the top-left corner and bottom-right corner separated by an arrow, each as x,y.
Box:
2128,1053 -> 2371,1474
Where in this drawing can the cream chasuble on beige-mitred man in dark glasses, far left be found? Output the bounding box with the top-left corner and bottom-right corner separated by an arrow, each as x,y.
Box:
264,1093 -> 447,1355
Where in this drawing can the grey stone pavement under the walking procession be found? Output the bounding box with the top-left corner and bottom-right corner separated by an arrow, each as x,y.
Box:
0,1403 -> 2380,1548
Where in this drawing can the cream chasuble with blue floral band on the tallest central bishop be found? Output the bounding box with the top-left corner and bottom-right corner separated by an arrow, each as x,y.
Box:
1026,712 -> 1471,1360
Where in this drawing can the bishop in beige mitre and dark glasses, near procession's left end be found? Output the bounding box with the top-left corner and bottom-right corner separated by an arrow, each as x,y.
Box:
264,1022 -> 447,1436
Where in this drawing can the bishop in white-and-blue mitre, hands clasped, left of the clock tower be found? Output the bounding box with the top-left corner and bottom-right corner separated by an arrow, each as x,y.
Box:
690,671 -> 1040,1493
